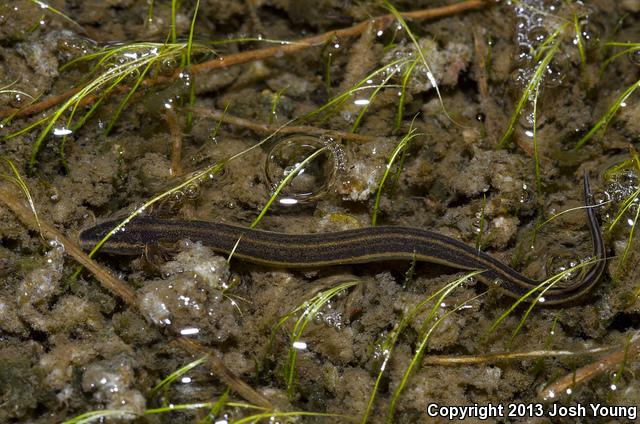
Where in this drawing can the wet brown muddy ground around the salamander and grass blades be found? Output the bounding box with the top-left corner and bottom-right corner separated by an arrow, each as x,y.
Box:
0,0 -> 640,423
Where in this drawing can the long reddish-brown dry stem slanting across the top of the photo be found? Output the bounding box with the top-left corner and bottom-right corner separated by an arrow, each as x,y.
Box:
0,0 -> 490,119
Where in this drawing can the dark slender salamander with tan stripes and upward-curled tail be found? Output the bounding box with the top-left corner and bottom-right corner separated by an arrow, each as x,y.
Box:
80,175 -> 605,304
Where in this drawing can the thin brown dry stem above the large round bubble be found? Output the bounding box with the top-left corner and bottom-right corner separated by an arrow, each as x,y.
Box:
187,107 -> 384,143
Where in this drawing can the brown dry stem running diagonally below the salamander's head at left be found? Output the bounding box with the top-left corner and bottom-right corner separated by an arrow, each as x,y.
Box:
0,187 -> 273,409
